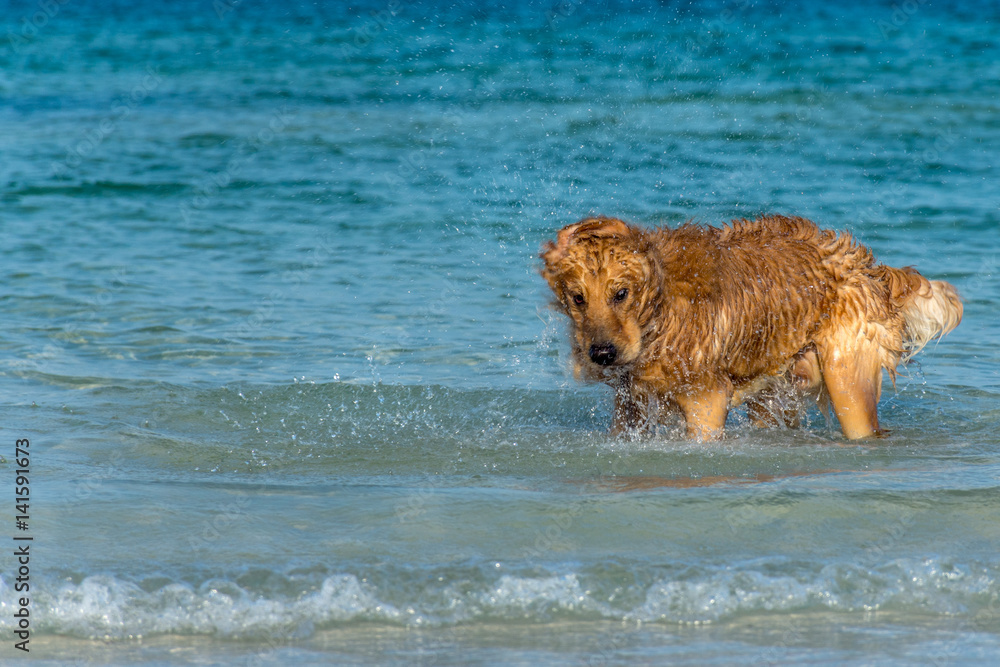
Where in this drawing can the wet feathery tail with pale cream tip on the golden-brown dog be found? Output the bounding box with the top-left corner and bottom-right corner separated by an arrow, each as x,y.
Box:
892,267 -> 963,363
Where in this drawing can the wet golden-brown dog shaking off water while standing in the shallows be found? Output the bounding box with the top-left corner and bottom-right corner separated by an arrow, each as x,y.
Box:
540,215 -> 962,440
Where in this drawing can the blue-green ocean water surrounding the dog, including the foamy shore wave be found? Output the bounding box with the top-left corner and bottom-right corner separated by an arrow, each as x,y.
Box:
0,0 -> 1000,665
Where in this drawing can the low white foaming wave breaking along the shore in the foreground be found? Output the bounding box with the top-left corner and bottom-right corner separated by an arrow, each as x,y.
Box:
0,558 -> 1000,640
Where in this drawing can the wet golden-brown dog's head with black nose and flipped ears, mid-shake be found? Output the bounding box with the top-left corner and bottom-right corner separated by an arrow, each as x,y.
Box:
541,218 -> 657,379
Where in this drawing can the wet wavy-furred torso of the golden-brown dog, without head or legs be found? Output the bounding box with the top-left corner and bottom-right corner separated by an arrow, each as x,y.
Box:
652,216 -> 874,383
